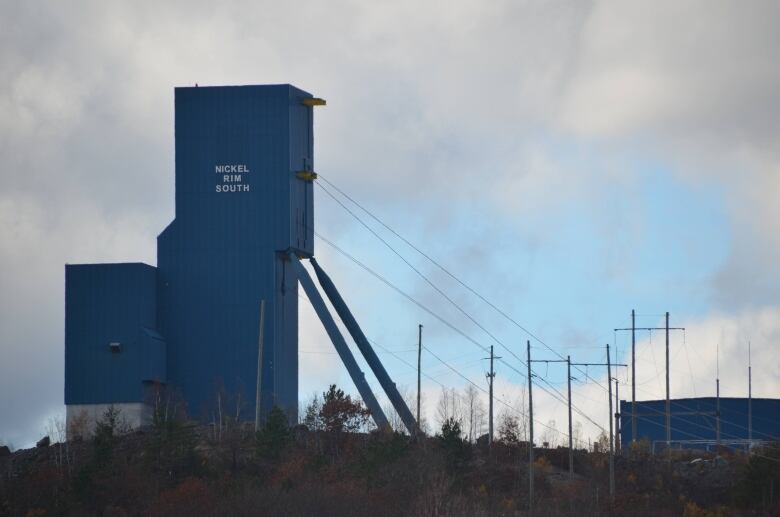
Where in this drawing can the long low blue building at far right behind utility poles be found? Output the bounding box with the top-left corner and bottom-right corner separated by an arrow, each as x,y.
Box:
619,397 -> 780,452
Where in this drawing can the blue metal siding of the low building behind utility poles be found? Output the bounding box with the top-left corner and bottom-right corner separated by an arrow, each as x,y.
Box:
620,397 -> 780,444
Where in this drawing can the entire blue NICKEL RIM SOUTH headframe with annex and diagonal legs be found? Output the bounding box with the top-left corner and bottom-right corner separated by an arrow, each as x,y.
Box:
65,85 -> 417,433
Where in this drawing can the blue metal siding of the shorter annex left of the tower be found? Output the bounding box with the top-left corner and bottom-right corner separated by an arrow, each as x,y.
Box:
65,264 -> 165,404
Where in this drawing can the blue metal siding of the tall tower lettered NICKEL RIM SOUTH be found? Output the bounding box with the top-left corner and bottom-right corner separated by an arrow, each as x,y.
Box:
158,85 -> 313,417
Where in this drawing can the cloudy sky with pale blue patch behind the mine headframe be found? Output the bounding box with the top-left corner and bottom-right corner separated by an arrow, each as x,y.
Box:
0,0 -> 780,447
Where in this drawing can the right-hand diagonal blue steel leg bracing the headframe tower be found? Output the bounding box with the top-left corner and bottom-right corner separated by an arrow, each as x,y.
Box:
310,257 -> 417,436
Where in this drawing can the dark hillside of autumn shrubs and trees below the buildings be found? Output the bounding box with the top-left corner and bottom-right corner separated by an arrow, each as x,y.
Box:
0,394 -> 780,517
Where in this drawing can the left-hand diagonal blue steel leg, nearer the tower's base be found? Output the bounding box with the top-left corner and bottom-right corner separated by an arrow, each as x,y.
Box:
288,252 -> 390,429
